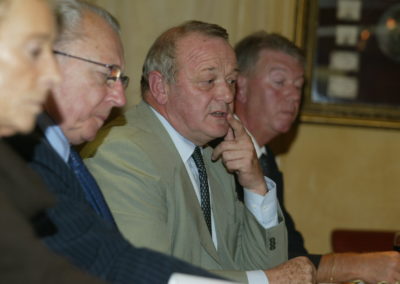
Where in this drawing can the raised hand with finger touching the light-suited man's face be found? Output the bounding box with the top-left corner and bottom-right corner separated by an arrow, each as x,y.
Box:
212,113 -> 268,195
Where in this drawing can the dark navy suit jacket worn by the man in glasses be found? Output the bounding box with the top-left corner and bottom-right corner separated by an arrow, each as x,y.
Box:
8,133 -> 219,283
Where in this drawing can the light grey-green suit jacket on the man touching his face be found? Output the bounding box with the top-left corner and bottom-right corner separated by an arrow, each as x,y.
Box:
86,102 -> 287,282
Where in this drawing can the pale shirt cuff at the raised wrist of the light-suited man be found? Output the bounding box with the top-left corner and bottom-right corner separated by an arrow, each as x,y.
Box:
244,177 -> 278,229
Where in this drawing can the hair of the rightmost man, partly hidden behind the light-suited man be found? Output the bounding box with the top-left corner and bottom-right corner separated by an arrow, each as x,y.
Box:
235,31 -> 305,74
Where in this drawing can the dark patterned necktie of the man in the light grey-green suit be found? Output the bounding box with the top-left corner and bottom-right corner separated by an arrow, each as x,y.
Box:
192,146 -> 211,234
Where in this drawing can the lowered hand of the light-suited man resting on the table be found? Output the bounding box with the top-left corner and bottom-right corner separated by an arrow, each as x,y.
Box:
264,256 -> 316,284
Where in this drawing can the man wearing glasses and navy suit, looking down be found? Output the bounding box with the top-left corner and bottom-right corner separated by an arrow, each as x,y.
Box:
9,0 -> 222,284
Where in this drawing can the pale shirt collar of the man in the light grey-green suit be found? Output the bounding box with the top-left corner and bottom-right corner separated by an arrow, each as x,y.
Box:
150,106 -> 196,163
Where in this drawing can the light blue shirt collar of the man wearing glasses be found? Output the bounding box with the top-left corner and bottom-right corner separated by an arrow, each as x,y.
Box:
38,113 -> 70,162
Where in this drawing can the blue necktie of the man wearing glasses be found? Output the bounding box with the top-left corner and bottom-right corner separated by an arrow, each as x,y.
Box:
68,148 -> 116,227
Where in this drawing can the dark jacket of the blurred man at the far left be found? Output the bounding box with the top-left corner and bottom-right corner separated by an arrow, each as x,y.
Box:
0,140 -> 108,284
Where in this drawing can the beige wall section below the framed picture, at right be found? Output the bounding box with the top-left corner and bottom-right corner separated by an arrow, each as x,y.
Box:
280,124 -> 400,253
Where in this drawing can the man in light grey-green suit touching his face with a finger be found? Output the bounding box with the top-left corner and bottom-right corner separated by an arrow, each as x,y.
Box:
85,21 -> 315,283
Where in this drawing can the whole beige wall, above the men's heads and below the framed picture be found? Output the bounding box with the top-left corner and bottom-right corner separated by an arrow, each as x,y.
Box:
88,0 -> 400,252
